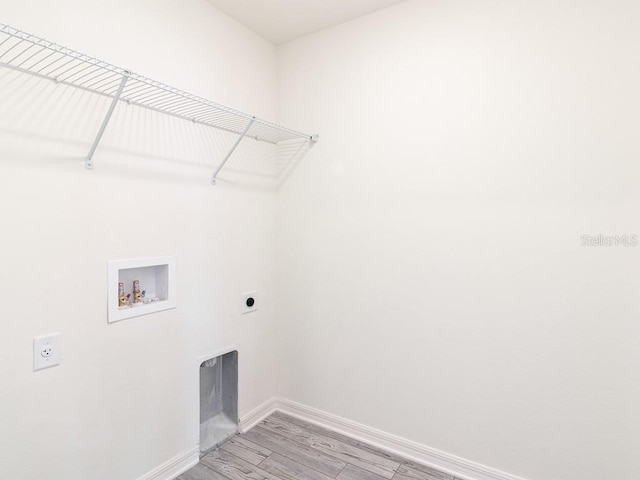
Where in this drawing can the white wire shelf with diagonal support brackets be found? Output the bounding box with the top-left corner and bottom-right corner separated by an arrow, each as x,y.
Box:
0,23 -> 318,184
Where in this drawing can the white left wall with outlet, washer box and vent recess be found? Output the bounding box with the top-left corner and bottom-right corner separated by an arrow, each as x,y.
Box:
0,0 -> 276,480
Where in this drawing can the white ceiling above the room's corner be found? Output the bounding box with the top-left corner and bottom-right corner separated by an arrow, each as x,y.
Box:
207,0 -> 404,45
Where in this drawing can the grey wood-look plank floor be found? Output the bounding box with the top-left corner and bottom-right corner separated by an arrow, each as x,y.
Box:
177,413 -> 457,480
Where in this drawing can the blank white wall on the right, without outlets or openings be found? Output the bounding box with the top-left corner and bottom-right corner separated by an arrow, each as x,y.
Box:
278,0 -> 640,480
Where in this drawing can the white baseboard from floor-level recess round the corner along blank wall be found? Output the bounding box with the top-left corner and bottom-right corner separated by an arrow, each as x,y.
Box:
272,398 -> 524,480
